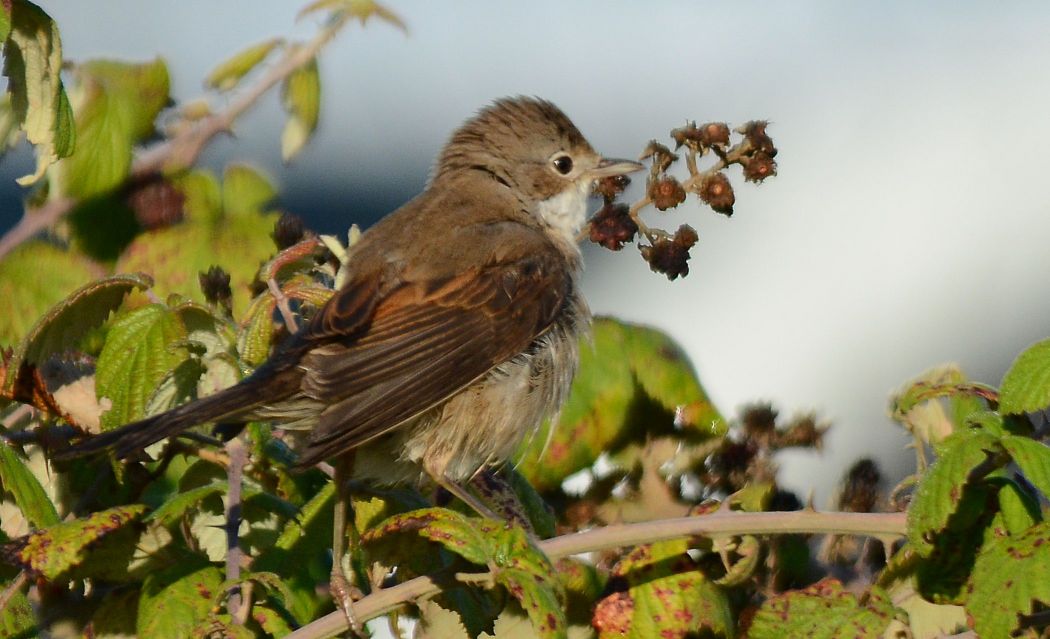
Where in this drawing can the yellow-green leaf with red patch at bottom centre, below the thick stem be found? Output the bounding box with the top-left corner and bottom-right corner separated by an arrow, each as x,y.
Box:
593,539 -> 734,639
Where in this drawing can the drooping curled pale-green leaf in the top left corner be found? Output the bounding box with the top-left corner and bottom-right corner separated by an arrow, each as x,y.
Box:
3,0 -> 77,186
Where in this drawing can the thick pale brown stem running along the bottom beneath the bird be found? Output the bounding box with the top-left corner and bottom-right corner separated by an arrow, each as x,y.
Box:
288,510 -> 907,639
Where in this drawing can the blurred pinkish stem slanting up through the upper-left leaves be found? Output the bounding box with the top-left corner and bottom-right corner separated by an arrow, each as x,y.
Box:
0,13 -> 351,258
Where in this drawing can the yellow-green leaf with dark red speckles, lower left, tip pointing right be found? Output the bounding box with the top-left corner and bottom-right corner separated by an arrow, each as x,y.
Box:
3,504 -> 146,581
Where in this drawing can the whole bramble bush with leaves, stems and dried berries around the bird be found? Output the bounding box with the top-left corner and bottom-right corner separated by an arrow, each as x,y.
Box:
0,0 -> 1050,639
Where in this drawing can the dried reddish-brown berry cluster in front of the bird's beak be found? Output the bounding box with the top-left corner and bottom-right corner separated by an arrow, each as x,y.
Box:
587,121 -> 777,280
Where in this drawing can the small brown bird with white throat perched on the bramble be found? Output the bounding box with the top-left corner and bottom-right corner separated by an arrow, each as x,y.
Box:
62,98 -> 643,508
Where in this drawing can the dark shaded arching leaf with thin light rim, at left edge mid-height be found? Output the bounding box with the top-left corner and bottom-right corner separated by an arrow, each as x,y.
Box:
3,265 -> 152,395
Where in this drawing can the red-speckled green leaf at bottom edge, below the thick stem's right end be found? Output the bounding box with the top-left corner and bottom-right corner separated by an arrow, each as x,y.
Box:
747,578 -> 898,639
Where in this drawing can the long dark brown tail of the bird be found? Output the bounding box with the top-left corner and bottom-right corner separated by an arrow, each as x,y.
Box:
54,374 -> 289,459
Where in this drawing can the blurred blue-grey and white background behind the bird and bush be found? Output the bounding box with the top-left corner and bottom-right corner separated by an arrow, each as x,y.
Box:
6,0 -> 1050,506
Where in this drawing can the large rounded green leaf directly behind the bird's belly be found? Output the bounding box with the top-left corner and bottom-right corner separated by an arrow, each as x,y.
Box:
518,318 -> 726,492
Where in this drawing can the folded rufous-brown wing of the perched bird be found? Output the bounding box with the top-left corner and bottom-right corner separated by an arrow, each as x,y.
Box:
291,237 -> 572,465
